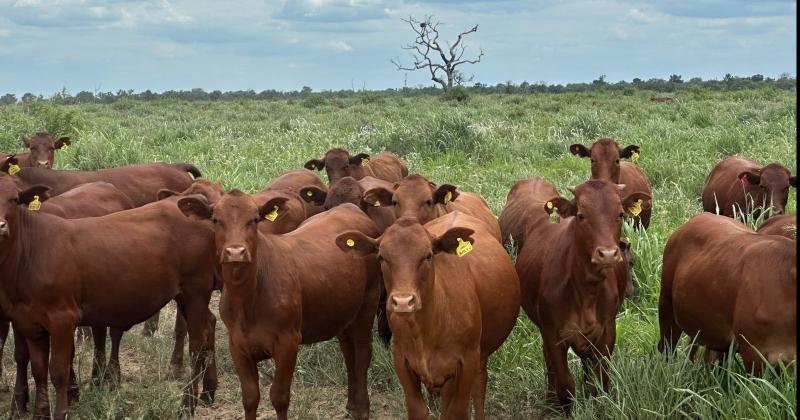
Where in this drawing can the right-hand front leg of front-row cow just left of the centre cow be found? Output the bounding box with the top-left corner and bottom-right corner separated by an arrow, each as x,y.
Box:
269,332 -> 300,420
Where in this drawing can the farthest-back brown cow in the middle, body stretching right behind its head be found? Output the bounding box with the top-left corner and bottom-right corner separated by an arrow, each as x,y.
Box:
304,148 -> 408,184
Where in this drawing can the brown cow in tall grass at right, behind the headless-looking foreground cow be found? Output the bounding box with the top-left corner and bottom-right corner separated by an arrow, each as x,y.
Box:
703,156 -> 797,218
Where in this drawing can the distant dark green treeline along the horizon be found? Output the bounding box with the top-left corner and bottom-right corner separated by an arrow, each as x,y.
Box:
0,73 -> 797,105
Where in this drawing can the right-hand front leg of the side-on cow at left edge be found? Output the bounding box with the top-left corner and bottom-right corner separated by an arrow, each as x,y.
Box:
50,323 -> 75,420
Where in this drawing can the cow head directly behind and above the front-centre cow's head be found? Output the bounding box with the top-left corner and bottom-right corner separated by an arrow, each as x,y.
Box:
364,174 -> 458,223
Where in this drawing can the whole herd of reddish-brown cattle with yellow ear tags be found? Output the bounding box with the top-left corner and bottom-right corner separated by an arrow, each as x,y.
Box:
0,133 -> 797,419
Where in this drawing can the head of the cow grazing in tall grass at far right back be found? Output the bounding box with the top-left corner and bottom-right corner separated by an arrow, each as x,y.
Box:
739,163 -> 797,216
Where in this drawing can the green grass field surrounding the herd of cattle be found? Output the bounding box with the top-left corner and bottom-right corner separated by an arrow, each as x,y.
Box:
0,89 -> 797,419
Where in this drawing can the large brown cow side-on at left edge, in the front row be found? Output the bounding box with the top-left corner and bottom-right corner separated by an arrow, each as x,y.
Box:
0,176 -> 216,419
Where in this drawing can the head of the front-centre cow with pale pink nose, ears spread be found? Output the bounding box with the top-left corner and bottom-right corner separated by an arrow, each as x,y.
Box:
336,217 -> 475,313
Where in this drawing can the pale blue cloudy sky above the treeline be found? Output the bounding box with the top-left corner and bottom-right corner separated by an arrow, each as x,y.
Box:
0,0 -> 797,97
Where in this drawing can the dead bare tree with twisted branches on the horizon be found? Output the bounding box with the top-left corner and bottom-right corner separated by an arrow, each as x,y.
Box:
391,16 -> 483,93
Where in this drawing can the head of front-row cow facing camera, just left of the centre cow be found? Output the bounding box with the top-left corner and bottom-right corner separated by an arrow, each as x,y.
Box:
177,189 -> 288,264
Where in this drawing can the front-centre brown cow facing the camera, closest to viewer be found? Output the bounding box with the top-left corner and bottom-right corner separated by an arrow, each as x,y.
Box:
336,211 -> 520,419
